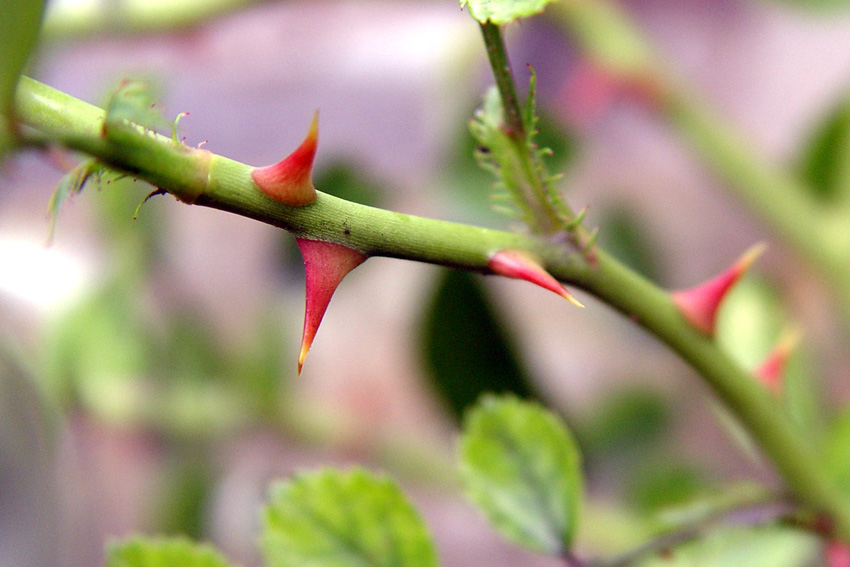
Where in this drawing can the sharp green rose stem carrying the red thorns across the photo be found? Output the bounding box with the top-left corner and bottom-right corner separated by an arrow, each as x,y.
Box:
11,77 -> 850,541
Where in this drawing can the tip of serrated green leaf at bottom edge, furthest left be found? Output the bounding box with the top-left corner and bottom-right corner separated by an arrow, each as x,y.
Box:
105,538 -> 230,567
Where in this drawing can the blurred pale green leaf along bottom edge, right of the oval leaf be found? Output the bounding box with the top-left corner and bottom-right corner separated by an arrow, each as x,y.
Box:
635,527 -> 820,567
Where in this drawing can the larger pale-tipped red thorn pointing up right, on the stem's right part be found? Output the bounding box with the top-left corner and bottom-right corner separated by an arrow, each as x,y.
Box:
672,243 -> 767,336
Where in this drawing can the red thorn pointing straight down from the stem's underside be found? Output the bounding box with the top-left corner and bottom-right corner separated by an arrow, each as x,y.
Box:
295,238 -> 367,374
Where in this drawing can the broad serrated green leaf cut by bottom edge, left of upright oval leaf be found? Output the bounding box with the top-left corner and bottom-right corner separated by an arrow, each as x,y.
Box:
262,469 -> 437,567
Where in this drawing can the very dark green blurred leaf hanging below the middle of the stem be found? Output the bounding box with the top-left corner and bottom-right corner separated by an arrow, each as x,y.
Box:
420,270 -> 535,421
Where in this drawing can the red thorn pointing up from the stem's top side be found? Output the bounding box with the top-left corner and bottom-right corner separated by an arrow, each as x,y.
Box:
251,111 -> 319,207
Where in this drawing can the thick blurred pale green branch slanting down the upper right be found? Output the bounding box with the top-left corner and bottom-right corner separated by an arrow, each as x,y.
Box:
548,0 -> 850,317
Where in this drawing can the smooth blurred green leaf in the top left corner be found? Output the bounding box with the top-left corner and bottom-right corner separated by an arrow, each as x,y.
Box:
0,0 -> 45,159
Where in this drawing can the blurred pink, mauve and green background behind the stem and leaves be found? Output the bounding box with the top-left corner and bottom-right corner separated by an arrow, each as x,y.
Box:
0,0 -> 850,567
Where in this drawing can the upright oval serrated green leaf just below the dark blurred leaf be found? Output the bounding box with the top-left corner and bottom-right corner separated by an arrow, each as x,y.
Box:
460,396 -> 583,556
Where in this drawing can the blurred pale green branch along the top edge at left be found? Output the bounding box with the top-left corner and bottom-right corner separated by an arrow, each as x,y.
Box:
41,0 -> 269,41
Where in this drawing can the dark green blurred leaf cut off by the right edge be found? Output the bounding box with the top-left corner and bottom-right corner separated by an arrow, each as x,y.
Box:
799,93 -> 850,200
